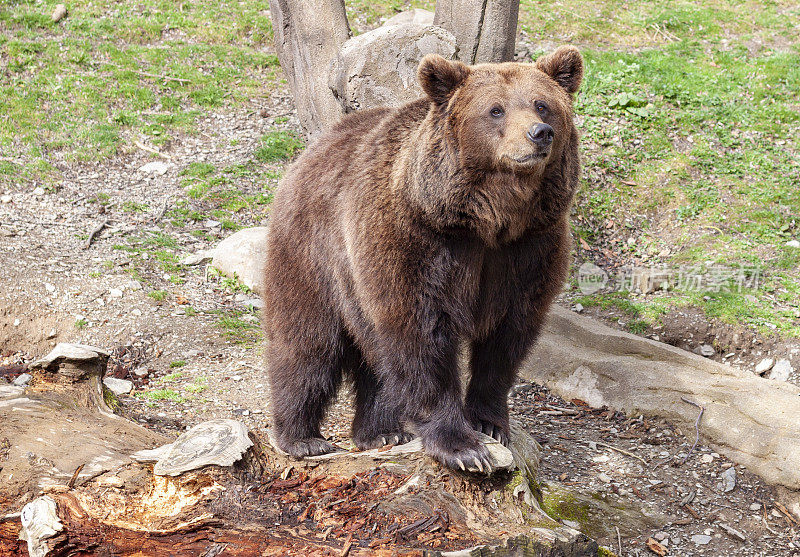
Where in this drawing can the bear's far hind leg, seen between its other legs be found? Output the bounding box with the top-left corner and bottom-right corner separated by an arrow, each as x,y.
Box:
353,362 -> 414,451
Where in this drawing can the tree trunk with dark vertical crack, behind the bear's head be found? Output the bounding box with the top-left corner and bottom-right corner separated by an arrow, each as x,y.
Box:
433,0 -> 519,64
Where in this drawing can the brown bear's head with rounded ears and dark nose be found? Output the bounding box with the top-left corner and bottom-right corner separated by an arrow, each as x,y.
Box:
418,46 -> 583,173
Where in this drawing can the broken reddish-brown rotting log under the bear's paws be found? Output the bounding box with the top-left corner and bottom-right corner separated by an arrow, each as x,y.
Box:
0,345 -> 597,556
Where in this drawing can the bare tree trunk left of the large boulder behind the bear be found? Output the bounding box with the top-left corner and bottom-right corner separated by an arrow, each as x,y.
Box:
269,0 -> 350,137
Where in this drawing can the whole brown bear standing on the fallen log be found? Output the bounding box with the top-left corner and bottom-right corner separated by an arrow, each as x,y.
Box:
263,46 -> 583,473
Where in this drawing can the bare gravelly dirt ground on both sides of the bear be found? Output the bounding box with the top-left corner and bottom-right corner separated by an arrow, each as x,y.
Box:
0,80 -> 800,556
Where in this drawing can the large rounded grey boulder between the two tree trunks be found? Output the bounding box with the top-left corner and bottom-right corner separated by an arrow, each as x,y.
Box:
328,23 -> 457,112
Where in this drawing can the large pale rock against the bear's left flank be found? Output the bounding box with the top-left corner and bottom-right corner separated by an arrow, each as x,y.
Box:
211,226 -> 267,292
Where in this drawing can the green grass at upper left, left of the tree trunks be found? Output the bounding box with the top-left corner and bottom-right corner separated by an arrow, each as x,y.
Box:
0,0 -> 279,187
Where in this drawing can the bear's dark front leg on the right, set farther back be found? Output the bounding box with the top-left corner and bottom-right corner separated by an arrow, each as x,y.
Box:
464,317 -> 541,445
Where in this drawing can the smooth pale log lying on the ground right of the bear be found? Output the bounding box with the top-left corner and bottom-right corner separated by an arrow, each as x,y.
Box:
521,306 -> 800,518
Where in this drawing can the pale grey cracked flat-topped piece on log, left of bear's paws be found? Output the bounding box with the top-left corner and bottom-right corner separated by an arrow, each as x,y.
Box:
131,420 -> 253,476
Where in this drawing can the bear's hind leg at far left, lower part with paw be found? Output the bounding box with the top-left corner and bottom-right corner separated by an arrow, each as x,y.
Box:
267,340 -> 342,458
